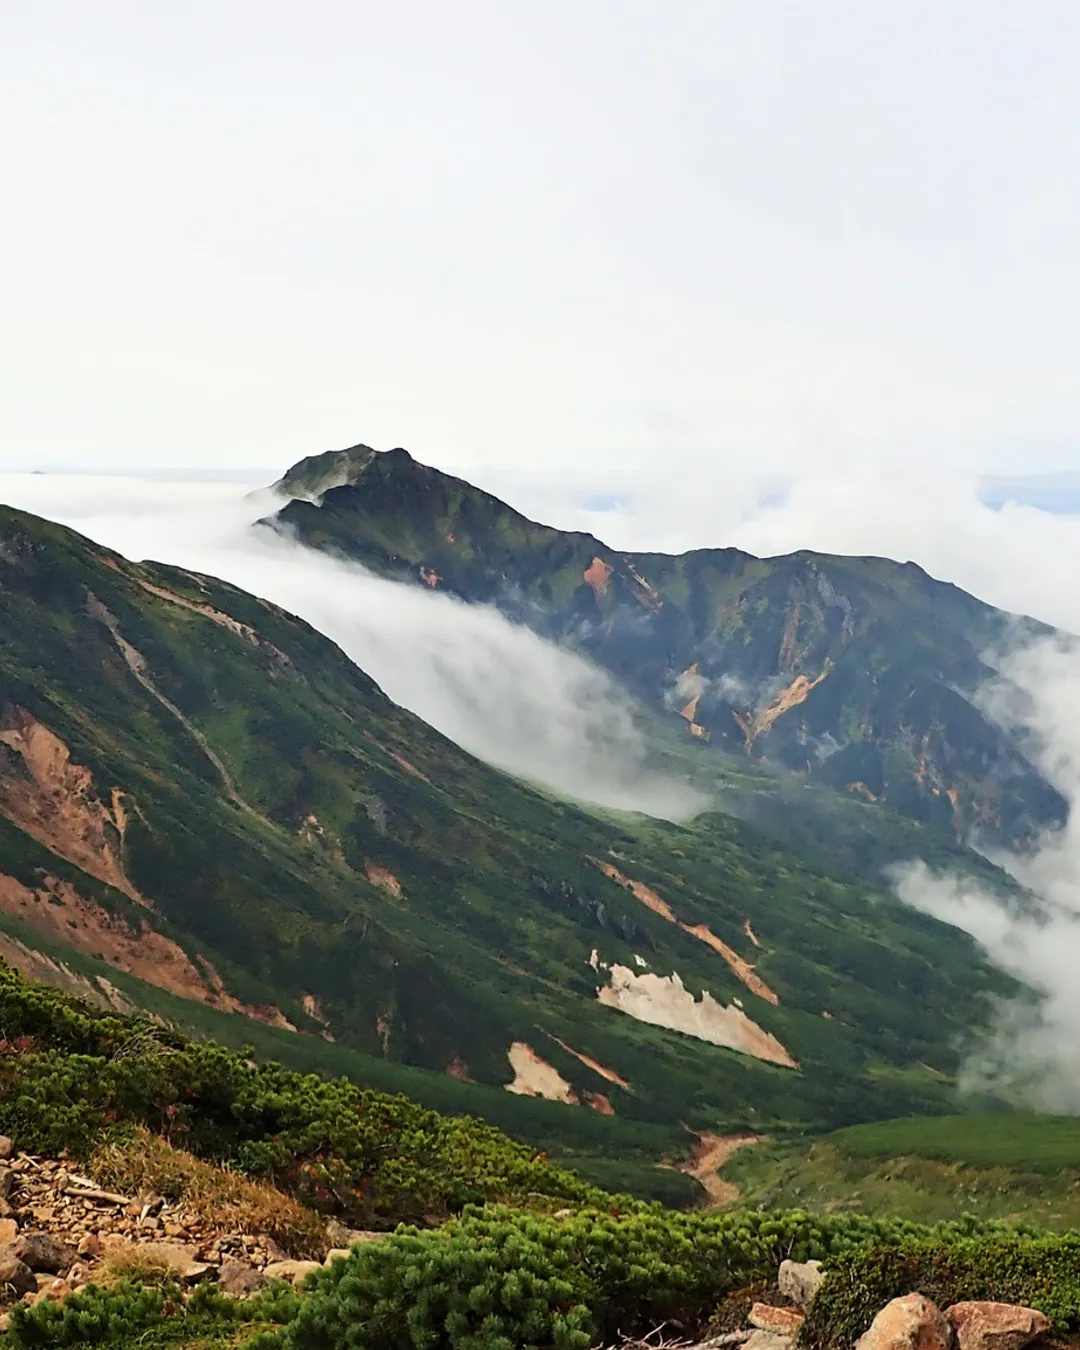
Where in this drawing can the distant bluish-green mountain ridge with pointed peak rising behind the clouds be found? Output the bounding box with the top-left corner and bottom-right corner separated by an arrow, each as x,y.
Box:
273,446 -> 1067,848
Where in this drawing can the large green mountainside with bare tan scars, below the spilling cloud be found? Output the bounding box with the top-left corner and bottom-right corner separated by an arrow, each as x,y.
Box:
0,509 -> 1011,1129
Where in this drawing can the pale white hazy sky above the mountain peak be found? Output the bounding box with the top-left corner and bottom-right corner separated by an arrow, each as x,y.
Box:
0,0 -> 1080,485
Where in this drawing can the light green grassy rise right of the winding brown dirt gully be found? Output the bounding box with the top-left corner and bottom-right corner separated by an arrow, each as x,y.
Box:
724,1115 -> 1080,1230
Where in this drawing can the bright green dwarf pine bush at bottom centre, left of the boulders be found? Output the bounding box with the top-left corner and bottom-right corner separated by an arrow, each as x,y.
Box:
267,1207 -> 912,1350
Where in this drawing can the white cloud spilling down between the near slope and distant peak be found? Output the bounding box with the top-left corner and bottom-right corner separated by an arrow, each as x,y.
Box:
0,475 -> 709,819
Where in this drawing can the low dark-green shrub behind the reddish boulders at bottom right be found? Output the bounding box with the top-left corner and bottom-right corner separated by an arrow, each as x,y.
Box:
802,1226 -> 1080,1350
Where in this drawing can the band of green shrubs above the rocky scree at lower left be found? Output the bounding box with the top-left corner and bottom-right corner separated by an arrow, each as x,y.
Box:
0,965 -> 607,1227
